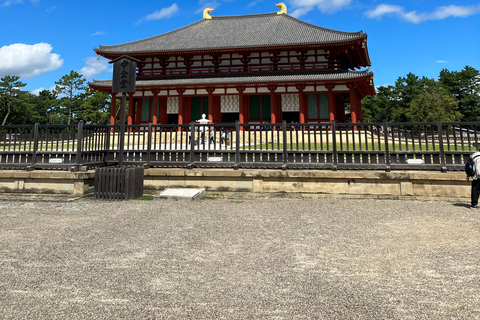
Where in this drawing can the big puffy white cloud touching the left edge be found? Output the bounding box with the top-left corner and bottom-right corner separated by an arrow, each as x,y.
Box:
0,43 -> 63,79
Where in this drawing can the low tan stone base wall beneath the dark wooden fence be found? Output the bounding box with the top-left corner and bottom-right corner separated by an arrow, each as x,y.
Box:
0,168 -> 471,201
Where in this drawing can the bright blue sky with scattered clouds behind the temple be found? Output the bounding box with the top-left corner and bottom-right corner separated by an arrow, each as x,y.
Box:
0,0 -> 480,92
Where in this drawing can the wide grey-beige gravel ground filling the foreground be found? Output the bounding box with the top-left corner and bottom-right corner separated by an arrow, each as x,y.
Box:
0,198 -> 480,319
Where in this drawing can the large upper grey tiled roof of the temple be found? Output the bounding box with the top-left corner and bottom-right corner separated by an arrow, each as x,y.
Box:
95,13 -> 367,54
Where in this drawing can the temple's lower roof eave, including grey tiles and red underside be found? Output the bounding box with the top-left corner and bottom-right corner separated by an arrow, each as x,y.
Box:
89,70 -> 375,95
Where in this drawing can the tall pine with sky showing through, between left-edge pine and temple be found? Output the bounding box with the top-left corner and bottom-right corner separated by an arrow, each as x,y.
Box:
55,70 -> 86,124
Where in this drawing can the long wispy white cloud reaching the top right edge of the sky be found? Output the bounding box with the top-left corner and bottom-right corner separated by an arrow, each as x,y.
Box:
365,4 -> 480,24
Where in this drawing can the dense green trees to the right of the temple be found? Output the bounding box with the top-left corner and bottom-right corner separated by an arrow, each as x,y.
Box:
362,66 -> 480,122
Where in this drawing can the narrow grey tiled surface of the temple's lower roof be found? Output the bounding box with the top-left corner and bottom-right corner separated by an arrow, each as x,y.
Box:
91,70 -> 373,88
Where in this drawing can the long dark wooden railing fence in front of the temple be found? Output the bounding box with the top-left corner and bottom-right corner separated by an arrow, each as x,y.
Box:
0,121 -> 480,171
